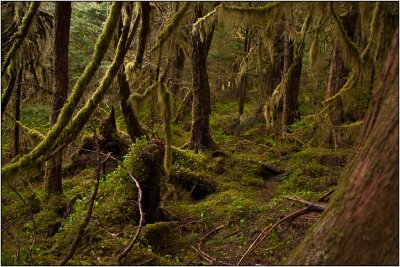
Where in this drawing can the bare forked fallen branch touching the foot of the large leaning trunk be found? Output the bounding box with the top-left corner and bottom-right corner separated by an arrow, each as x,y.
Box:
237,196 -> 325,265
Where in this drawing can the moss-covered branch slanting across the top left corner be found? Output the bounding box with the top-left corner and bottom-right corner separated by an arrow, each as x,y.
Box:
1,1 -> 40,77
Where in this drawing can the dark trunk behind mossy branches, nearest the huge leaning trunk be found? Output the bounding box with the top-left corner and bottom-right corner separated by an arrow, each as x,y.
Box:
326,5 -> 358,125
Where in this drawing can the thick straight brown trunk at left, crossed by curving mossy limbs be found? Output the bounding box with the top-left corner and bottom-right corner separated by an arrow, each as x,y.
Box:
45,2 -> 71,195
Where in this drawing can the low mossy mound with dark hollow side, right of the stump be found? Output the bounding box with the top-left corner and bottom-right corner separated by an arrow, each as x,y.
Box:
170,168 -> 217,200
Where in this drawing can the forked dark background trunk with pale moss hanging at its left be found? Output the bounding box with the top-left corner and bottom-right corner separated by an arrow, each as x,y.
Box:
282,18 -> 304,132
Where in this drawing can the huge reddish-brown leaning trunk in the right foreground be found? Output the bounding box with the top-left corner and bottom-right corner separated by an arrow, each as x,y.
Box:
288,29 -> 399,265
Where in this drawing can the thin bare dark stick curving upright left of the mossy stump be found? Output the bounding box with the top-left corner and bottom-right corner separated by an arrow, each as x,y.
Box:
60,130 -> 101,265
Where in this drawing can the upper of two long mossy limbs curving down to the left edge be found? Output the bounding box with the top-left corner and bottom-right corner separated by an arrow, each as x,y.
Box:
1,2 -> 123,179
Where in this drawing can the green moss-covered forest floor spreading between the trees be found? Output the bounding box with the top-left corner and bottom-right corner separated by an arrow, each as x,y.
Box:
1,100 -> 350,265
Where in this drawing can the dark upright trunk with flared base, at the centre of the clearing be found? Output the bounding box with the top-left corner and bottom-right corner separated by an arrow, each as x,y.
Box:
185,3 -> 215,151
